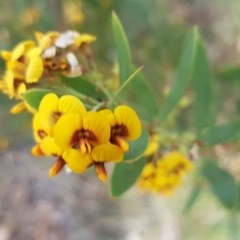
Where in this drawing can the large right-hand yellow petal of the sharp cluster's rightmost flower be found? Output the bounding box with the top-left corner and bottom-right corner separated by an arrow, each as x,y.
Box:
114,105 -> 142,140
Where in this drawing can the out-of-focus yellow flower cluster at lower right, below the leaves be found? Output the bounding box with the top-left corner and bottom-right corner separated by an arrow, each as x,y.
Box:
138,151 -> 193,195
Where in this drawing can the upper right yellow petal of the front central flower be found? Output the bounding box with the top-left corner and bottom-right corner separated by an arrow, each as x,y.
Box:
83,112 -> 111,146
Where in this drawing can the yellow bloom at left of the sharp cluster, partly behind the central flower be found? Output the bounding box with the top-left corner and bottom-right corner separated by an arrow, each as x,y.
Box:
32,93 -> 86,176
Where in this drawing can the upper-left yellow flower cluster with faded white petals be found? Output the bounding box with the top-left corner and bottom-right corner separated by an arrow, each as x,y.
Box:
0,31 -> 95,113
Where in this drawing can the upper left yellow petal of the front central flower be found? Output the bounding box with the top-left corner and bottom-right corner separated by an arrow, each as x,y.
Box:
54,113 -> 82,149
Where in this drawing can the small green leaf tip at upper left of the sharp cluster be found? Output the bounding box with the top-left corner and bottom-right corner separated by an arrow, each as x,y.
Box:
23,89 -> 52,110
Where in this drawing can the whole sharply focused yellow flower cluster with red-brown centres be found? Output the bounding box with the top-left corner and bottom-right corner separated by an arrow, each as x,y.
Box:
32,93 -> 141,181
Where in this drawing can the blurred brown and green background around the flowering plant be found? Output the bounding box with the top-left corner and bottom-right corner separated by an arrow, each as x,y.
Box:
0,0 -> 240,240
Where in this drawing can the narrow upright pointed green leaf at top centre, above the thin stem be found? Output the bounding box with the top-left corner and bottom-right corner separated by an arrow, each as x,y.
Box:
112,12 -> 132,85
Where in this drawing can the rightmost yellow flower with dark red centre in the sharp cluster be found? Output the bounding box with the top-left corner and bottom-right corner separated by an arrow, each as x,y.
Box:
100,105 -> 142,152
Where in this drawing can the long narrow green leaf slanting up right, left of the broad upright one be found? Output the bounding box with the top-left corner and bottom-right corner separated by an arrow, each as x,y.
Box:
159,28 -> 198,120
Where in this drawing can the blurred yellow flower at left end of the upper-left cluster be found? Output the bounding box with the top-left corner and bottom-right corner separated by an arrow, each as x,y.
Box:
0,41 -> 43,102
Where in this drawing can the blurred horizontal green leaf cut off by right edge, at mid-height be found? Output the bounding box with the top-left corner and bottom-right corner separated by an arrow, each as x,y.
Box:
201,121 -> 240,145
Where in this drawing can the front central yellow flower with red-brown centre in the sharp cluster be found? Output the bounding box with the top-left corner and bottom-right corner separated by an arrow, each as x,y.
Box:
54,112 -> 123,181
